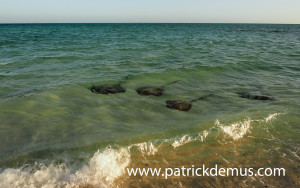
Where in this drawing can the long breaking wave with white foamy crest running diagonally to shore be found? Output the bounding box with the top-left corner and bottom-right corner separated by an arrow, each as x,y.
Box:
0,113 -> 282,188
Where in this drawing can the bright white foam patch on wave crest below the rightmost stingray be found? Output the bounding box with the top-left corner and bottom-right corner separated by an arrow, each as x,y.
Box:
215,118 -> 251,140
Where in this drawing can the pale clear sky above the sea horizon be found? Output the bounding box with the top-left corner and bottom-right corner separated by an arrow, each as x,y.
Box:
0,0 -> 300,24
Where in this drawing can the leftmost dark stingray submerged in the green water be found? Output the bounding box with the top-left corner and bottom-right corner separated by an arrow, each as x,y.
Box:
90,76 -> 129,94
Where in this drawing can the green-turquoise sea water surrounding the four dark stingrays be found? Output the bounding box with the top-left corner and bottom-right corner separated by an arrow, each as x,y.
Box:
0,24 -> 300,187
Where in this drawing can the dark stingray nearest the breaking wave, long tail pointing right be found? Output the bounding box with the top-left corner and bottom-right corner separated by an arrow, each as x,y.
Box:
166,94 -> 212,111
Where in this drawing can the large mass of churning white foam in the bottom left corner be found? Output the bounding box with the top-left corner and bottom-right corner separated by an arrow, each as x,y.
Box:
0,148 -> 130,188
